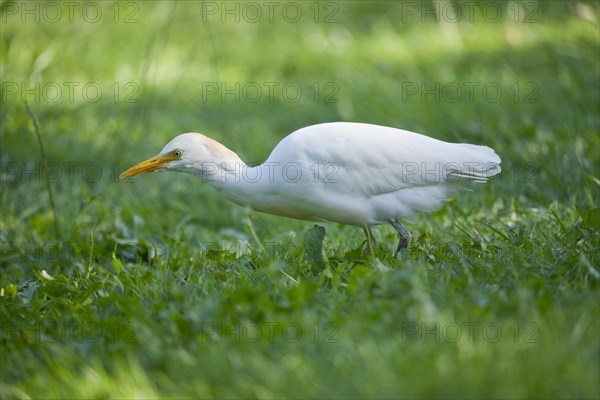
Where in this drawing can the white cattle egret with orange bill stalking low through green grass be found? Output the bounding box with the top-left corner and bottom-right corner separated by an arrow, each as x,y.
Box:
120,122 -> 500,255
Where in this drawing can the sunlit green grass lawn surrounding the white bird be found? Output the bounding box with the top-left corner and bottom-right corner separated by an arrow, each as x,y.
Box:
0,1 -> 600,398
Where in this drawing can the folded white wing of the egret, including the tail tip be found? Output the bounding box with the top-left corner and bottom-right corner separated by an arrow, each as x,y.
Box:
268,123 -> 500,222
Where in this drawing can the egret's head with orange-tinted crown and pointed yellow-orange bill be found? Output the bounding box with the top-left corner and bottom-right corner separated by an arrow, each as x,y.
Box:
120,133 -> 239,179
